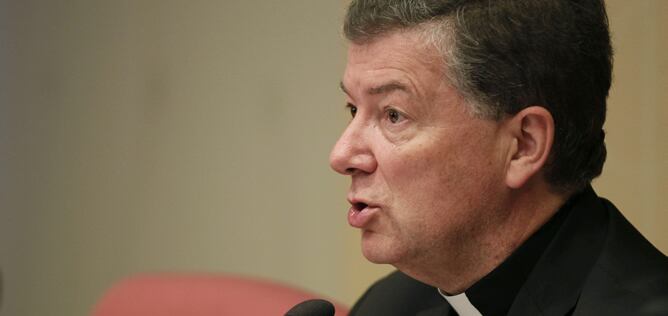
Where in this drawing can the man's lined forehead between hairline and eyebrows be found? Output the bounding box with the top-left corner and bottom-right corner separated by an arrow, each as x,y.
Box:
342,31 -> 444,99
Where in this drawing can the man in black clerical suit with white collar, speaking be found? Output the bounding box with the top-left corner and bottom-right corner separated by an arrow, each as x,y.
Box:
330,0 -> 668,315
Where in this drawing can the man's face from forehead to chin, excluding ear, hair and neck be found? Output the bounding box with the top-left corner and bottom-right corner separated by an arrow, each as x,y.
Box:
330,31 -> 507,270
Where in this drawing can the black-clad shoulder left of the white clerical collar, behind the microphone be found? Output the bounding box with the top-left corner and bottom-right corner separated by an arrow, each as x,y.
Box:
350,271 -> 448,316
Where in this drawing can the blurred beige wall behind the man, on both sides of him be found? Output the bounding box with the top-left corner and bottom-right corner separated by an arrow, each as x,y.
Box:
0,0 -> 668,316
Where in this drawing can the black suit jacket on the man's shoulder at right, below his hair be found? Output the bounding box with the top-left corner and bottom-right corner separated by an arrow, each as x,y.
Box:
510,189 -> 668,315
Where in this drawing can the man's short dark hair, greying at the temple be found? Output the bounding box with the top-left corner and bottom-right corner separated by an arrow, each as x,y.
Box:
344,0 -> 612,192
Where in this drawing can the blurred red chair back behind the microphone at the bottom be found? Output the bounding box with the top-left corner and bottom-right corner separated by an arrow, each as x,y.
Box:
91,274 -> 348,316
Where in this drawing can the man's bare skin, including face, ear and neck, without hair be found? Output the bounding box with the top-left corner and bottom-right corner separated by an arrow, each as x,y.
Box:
330,31 -> 564,294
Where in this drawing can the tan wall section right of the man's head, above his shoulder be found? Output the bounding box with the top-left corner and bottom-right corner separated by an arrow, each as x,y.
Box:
595,0 -> 668,253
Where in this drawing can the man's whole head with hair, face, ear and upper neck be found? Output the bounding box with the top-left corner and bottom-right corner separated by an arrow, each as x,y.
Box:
330,0 -> 610,290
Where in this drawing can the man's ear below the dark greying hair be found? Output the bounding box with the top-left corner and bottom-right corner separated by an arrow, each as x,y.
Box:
506,106 -> 554,189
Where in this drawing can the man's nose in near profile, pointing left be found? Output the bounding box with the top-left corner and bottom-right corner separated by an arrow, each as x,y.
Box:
329,120 -> 377,175
